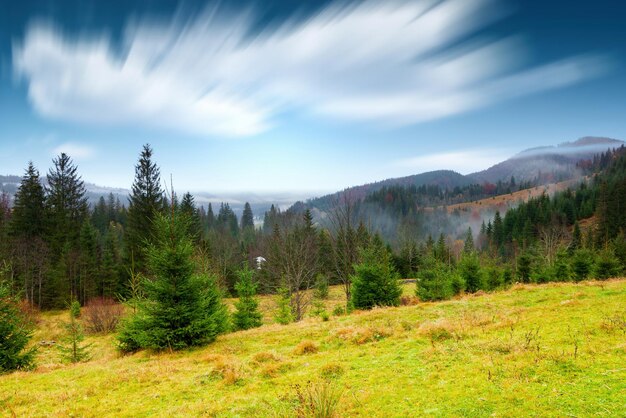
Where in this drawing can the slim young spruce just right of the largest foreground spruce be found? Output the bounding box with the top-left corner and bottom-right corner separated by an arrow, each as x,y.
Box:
233,265 -> 263,330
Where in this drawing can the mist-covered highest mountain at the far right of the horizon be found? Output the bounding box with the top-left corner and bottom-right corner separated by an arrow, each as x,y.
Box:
467,136 -> 625,184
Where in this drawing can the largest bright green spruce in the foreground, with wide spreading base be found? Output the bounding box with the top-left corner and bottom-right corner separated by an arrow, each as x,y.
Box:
118,214 -> 227,352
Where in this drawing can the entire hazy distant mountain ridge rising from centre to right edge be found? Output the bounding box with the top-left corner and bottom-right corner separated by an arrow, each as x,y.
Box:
307,136 -> 626,210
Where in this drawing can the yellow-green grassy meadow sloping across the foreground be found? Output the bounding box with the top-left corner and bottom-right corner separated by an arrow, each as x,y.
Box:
0,279 -> 626,417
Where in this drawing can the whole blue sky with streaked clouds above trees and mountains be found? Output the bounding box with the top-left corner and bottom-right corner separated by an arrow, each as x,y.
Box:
0,0 -> 626,196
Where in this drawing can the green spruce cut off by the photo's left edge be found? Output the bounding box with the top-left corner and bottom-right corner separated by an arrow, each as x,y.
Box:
0,282 -> 35,373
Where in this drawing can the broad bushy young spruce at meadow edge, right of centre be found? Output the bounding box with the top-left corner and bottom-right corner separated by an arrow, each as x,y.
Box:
351,247 -> 402,309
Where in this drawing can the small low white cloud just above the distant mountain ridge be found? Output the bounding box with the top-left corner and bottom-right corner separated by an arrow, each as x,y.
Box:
395,149 -> 512,174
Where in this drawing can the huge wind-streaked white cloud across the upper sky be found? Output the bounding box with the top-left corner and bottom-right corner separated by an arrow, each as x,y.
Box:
13,0 -> 605,136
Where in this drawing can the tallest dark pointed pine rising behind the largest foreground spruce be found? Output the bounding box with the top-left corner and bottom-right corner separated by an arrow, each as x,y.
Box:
126,144 -> 164,272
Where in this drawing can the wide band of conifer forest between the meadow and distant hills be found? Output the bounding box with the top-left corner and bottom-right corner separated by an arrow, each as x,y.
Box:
0,145 -> 626,367
